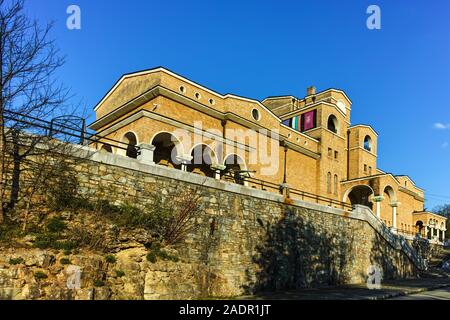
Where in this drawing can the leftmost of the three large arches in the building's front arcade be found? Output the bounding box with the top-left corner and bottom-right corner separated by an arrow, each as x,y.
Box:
150,131 -> 183,169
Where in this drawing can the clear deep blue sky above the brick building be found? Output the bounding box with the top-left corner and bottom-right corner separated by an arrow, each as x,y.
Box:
27,0 -> 450,208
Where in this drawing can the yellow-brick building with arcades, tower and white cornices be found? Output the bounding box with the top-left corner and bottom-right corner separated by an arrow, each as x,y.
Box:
90,68 -> 446,242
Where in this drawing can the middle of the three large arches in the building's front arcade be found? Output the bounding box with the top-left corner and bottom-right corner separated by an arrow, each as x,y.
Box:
187,143 -> 217,178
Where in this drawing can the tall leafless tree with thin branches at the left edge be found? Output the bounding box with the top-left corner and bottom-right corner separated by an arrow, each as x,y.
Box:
0,0 -> 74,222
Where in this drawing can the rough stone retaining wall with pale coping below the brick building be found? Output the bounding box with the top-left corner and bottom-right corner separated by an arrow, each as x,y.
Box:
0,148 -> 421,299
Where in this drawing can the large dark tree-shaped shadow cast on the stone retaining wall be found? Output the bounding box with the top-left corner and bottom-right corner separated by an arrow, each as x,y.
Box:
244,208 -> 354,294
